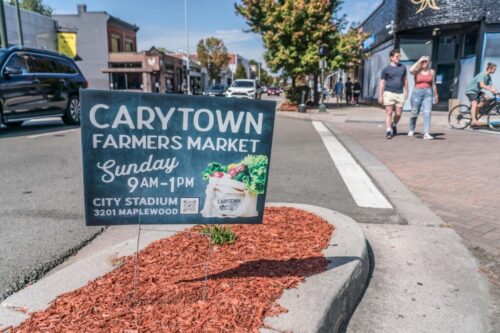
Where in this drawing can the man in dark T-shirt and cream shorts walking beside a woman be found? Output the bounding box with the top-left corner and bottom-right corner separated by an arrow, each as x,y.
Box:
378,49 -> 408,139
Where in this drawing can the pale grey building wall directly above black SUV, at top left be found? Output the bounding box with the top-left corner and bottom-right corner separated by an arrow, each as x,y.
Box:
4,3 -> 57,51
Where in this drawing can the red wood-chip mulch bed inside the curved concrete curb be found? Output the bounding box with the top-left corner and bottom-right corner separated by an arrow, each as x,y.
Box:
8,207 -> 333,333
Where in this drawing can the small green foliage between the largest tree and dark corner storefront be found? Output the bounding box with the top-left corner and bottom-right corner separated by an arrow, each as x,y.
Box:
330,27 -> 369,71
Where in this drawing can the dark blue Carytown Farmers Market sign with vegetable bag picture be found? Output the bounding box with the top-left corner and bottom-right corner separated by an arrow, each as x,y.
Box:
80,90 -> 276,225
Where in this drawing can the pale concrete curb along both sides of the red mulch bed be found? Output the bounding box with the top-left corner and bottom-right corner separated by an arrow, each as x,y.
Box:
0,203 -> 370,333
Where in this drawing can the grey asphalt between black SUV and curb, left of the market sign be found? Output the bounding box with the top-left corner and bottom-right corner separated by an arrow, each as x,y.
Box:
0,120 -> 101,300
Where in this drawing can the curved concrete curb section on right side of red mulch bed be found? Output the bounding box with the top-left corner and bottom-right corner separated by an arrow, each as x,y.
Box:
261,204 -> 370,333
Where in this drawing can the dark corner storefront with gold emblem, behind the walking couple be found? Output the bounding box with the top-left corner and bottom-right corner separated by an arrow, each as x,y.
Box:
361,0 -> 500,110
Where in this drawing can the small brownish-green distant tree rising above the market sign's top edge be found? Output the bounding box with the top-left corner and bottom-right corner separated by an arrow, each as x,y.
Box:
196,37 -> 229,82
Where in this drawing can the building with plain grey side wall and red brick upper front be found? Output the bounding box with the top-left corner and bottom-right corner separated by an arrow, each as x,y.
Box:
53,5 -> 139,89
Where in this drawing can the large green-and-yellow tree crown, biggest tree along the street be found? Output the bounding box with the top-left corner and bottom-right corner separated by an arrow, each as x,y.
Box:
235,0 -> 342,85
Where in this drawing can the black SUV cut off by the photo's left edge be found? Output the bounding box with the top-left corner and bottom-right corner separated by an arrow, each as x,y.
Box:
0,47 -> 87,127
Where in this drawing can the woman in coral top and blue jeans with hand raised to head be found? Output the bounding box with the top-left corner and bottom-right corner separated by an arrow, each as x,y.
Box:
408,56 -> 438,140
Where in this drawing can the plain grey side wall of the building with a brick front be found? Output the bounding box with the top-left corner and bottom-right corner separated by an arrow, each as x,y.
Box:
53,12 -> 109,90
